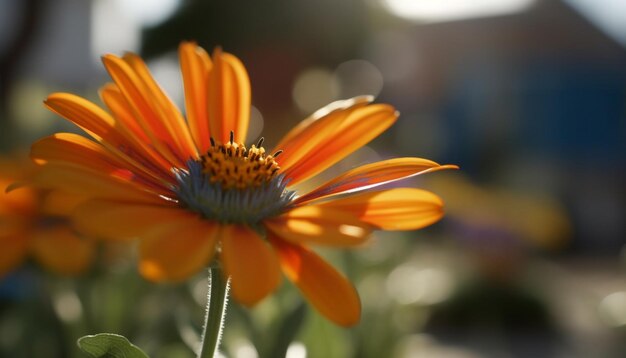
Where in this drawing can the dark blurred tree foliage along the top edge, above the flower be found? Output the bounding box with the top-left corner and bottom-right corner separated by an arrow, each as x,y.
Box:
142,0 -> 367,62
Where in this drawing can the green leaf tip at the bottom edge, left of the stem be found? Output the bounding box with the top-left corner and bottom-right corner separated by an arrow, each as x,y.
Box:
76,333 -> 148,358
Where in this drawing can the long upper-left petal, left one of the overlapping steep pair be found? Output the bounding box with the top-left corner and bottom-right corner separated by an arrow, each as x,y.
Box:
102,55 -> 190,167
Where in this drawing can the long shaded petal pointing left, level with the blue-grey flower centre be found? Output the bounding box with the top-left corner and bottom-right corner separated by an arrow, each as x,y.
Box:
28,164 -> 166,205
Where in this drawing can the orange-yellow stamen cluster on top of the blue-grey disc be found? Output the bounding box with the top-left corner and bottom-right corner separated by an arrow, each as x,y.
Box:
199,136 -> 280,189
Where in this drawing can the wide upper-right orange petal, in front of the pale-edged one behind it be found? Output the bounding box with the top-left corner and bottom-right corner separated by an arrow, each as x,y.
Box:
278,101 -> 398,185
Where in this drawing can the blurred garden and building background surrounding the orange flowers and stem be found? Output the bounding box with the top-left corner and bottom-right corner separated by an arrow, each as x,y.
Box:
0,0 -> 626,358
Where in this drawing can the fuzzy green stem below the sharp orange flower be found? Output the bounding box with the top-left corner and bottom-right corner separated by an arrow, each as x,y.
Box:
198,265 -> 228,358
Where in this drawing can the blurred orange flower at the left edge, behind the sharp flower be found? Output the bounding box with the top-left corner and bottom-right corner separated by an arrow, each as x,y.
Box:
0,158 -> 95,279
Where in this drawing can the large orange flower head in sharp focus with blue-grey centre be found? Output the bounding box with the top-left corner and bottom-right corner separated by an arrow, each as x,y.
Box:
32,43 -> 453,325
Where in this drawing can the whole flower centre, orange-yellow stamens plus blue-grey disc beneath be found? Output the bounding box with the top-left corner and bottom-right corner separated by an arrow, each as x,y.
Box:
174,132 -> 295,226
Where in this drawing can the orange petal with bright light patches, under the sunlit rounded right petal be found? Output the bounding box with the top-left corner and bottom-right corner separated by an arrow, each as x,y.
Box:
264,205 -> 371,246
